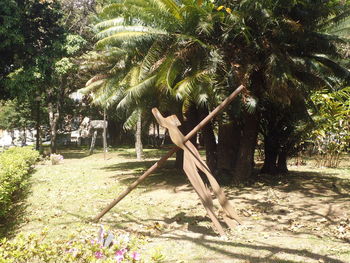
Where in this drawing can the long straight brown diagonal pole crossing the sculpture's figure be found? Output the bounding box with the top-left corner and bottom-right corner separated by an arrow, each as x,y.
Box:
92,85 -> 244,222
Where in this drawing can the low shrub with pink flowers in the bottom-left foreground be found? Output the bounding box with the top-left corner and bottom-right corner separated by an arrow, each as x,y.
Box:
0,228 -> 164,263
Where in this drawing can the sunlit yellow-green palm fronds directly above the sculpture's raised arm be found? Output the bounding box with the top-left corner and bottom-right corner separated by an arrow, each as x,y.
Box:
85,1 -> 221,163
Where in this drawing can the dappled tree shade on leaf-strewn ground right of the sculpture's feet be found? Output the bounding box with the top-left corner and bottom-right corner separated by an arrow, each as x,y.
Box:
220,171 -> 350,243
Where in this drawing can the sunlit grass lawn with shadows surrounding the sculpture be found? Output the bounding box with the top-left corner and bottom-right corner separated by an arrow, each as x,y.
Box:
1,148 -> 350,263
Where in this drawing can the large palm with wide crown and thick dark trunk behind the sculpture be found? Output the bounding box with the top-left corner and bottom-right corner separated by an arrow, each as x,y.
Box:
87,0 -> 349,185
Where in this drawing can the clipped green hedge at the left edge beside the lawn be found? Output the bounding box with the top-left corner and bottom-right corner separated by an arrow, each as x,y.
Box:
0,147 -> 39,218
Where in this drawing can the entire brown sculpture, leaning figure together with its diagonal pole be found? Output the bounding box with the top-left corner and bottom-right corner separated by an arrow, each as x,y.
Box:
92,85 -> 244,235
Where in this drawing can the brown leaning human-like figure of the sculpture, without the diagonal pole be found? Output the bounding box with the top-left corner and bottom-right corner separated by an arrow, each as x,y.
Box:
152,108 -> 240,235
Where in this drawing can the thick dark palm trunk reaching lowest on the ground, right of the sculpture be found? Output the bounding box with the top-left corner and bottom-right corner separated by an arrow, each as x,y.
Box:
232,112 -> 259,184
